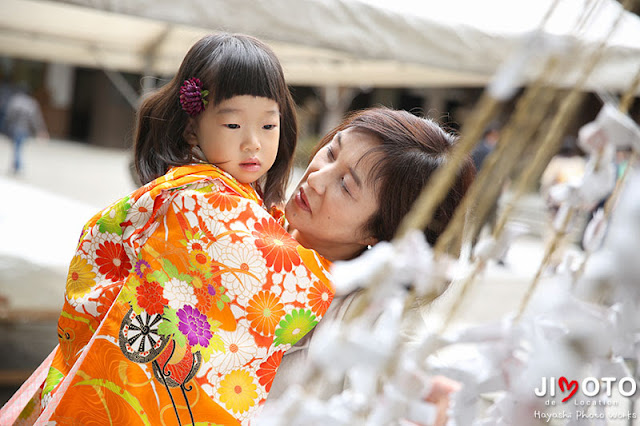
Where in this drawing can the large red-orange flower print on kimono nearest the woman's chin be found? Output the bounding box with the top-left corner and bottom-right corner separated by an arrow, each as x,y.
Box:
253,218 -> 300,272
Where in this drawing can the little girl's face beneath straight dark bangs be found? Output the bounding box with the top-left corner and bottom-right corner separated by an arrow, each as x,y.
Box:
185,95 -> 280,183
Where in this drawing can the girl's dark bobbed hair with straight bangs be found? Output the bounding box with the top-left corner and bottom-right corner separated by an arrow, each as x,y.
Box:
134,33 -> 298,205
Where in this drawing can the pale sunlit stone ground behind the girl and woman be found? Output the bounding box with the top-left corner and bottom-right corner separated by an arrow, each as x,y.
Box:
0,136 -> 544,405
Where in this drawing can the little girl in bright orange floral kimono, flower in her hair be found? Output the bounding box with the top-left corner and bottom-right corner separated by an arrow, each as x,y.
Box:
0,34 -> 333,425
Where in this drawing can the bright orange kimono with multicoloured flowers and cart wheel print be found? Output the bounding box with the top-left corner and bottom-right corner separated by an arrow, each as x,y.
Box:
0,164 -> 334,425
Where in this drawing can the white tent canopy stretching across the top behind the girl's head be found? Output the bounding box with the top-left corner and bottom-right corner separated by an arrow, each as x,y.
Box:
0,0 -> 640,91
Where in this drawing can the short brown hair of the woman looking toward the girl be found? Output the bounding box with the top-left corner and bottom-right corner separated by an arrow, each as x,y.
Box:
316,108 -> 476,245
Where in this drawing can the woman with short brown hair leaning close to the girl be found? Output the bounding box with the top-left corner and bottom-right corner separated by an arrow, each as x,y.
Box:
266,108 -> 475,425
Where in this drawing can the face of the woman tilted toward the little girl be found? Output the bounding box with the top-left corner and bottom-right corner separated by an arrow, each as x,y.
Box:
285,128 -> 379,260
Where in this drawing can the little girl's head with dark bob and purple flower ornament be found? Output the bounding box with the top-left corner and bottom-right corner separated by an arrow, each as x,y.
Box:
135,31 -> 297,206
